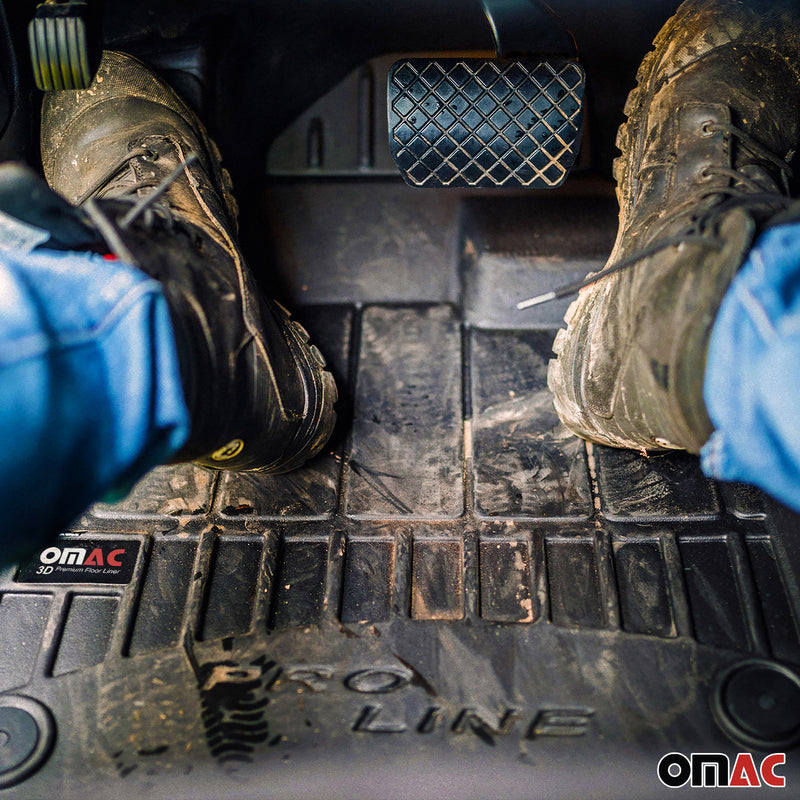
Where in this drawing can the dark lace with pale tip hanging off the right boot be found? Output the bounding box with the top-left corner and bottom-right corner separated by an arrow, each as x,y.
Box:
516,122 -> 792,310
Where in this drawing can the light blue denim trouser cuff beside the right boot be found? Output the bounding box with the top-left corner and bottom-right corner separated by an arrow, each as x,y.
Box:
701,223 -> 800,510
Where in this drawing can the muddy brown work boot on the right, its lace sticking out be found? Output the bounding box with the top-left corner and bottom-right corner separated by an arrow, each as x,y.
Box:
548,0 -> 800,453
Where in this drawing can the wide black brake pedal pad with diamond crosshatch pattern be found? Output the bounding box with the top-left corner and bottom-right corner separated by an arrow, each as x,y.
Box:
387,58 -> 586,188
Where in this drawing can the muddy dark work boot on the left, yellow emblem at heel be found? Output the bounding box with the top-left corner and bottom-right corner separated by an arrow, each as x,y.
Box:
42,52 -> 336,472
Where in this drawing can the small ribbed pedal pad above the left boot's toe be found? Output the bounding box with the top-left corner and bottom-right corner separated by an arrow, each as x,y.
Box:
28,0 -> 94,92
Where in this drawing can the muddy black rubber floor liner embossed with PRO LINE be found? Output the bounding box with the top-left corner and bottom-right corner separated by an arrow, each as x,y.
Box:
0,181 -> 800,798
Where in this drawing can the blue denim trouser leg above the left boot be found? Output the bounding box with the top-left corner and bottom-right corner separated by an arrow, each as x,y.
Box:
0,251 -> 189,561
